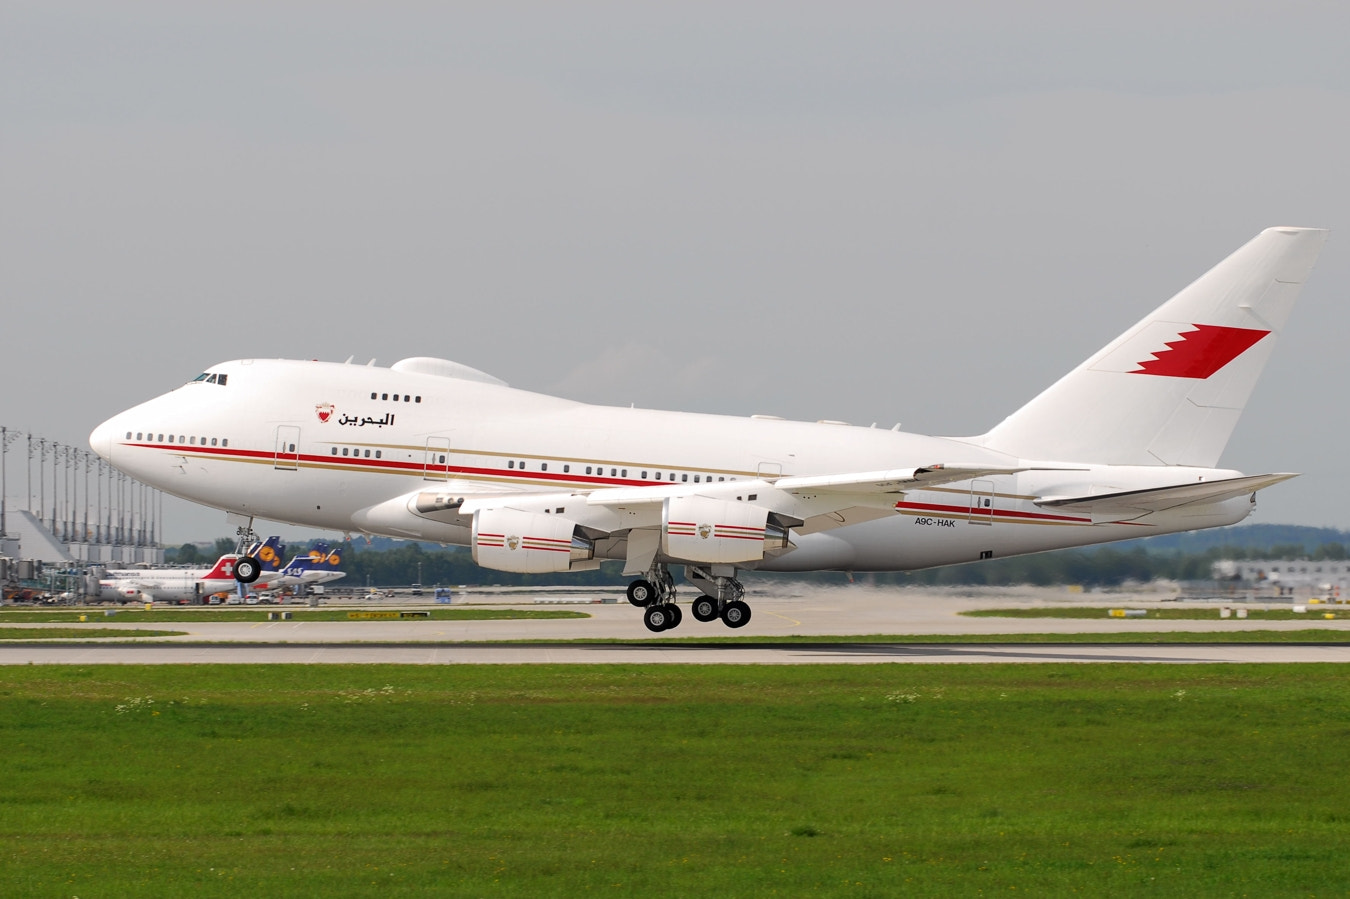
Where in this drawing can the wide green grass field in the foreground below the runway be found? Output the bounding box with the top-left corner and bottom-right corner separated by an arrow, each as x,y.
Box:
0,665 -> 1350,899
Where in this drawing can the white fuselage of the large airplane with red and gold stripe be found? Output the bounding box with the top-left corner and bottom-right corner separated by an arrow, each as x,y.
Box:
92,359 -> 1253,571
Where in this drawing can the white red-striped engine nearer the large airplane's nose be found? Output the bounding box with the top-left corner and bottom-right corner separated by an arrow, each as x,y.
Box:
471,509 -> 599,574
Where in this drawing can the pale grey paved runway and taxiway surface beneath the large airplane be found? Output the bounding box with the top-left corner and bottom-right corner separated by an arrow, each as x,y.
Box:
0,586 -> 1350,664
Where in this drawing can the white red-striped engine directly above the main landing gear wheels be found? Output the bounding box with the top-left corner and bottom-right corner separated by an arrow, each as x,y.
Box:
662,497 -> 787,564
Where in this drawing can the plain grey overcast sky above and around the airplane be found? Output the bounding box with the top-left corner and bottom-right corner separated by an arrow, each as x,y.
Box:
0,0 -> 1350,543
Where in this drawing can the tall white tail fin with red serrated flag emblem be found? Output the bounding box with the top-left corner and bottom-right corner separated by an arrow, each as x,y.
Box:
975,228 -> 1327,468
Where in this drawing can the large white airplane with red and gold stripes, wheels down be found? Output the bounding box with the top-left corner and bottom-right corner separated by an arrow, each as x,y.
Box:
89,228 -> 1326,632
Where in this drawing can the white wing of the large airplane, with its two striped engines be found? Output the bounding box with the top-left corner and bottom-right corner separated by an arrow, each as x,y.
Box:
352,463 -> 1029,572
